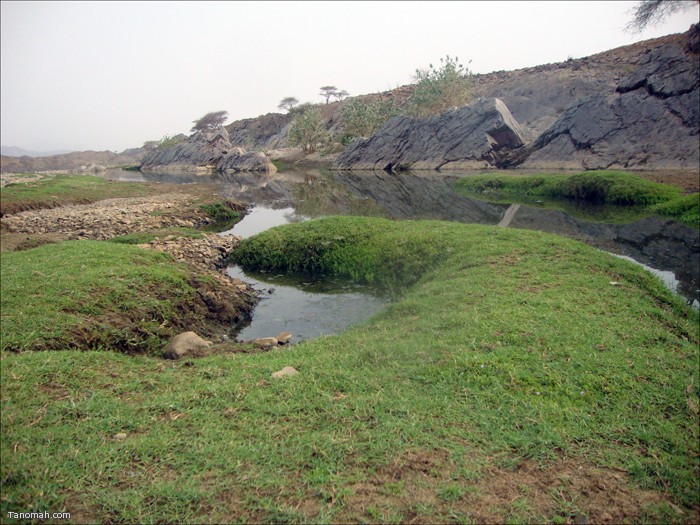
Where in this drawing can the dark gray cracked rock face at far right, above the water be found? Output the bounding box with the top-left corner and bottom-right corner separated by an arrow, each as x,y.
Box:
515,44 -> 700,169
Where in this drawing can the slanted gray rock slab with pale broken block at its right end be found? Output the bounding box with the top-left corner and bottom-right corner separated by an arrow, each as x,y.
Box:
334,98 -> 524,171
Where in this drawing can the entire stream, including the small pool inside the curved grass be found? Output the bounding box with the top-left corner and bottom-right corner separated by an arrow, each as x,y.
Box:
106,169 -> 700,342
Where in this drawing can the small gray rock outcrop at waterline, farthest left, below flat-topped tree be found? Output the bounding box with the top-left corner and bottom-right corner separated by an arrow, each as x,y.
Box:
141,128 -> 276,172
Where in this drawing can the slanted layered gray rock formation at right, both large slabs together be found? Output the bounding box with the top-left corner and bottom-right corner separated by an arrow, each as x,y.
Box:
334,27 -> 700,171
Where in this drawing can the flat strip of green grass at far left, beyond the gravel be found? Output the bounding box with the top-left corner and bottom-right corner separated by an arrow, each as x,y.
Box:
0,175 -> 153,215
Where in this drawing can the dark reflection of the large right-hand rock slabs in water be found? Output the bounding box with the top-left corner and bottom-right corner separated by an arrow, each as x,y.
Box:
333,171 -> 700,300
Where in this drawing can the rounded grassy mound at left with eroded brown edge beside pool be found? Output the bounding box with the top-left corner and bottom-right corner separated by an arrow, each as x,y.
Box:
0,241 -> 252,352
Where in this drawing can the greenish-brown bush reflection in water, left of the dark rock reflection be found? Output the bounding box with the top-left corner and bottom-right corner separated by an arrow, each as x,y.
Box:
292,170 -> 386,217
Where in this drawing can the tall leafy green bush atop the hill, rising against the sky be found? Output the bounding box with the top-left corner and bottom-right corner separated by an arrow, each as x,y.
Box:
408,55 -> 471,117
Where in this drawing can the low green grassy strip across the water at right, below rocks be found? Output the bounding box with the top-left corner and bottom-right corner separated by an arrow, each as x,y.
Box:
457,171 -> 700,228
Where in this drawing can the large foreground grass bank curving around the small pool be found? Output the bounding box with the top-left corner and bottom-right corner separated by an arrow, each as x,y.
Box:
0,217 -> 700,523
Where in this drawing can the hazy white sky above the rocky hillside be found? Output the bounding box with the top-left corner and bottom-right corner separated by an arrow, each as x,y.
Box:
0,1 -> 698,151
